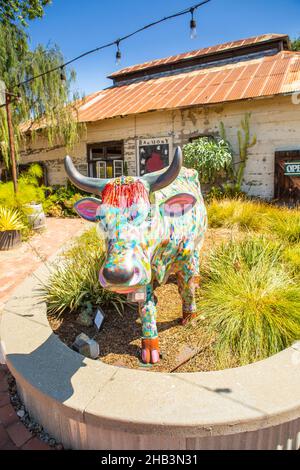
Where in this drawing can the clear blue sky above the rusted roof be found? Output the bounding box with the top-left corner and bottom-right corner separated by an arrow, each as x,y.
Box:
28,0 -> 300,95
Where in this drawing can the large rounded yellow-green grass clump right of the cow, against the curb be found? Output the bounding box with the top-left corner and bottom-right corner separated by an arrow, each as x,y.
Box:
198,237 -> 300,366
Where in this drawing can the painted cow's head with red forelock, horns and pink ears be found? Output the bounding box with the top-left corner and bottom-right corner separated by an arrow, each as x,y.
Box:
65,147 -> 192,293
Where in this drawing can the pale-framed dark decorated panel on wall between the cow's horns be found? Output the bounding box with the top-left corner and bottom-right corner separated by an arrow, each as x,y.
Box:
137,137 -> 171,176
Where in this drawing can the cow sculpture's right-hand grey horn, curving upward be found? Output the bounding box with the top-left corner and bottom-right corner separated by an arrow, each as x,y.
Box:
143,147 -> 182,191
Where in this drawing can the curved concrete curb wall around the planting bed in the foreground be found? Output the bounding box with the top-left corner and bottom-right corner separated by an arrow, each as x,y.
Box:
1,260 -> 300,449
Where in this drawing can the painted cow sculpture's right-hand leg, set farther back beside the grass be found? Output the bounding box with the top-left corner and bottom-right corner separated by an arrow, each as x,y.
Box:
177,271 -> 199,325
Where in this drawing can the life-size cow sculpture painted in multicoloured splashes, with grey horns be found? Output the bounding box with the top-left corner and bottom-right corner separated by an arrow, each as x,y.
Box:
65,147 -> 207,364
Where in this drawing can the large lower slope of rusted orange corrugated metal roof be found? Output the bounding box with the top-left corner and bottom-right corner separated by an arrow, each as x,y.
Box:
78,51 -> 300,122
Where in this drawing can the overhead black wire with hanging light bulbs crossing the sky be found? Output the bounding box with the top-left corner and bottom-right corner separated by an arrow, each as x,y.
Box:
15,0 -> 211,87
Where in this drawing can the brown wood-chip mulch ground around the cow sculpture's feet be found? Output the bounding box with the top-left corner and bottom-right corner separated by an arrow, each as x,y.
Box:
48,229 -> 239,372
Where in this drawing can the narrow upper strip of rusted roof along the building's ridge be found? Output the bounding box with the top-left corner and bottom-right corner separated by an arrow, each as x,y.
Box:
109,33 -> 288,78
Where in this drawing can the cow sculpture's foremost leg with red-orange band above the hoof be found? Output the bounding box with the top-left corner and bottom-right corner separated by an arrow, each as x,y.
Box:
140,285 -> 159,364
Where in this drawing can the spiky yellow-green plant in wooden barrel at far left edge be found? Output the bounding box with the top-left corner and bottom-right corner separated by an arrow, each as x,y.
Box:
0,206 -> 25,250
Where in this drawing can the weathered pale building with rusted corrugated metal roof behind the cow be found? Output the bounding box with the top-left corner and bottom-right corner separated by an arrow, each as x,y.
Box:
19,34 -> 300,198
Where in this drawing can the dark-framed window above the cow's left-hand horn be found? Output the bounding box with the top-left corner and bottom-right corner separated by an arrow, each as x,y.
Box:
87,141 -> 124,178
